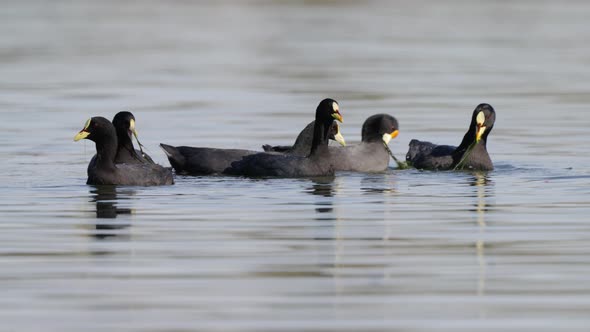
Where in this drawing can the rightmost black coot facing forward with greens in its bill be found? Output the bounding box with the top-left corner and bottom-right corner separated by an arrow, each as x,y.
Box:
406,104 -> 496,171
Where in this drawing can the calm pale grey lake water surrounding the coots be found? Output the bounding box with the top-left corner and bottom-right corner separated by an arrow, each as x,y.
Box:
0,0 -> 590,331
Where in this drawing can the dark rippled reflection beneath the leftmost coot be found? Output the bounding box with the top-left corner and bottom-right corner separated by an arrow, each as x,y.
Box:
90,186 -> 135,239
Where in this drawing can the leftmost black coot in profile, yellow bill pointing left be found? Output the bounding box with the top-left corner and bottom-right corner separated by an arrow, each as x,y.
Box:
74,117 -> 174,186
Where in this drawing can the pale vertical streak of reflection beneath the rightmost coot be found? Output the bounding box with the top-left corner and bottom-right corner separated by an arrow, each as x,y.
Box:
469,172 -> 493,296
